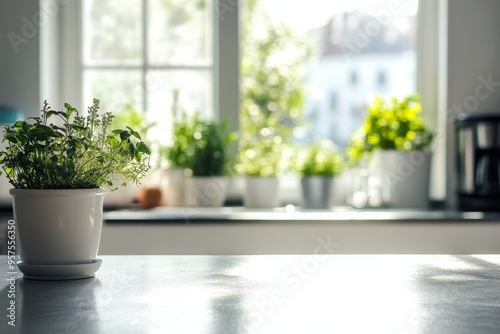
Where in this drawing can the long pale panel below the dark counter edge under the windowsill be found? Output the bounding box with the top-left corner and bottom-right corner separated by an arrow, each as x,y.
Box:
99,221 -> 500,255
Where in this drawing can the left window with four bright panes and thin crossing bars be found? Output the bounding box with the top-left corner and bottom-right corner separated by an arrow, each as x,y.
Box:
81,0 -> 214,141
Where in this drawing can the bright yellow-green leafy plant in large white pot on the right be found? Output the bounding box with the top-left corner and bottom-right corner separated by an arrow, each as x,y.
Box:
348,94 -> 433,208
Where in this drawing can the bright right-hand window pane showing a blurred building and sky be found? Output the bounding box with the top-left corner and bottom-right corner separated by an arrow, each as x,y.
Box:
248,0 -> 418,148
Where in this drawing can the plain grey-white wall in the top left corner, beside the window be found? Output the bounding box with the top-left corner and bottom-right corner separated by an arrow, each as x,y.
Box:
0,0 -> 42,116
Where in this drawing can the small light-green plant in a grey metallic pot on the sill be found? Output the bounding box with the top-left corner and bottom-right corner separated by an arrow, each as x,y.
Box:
295,141 -> 344,209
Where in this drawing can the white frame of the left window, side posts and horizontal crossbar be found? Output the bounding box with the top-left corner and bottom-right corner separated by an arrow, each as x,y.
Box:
52,0 -> 240,135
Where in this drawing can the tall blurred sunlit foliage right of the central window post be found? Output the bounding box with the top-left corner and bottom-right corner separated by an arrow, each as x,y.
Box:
236,0 -> 313,177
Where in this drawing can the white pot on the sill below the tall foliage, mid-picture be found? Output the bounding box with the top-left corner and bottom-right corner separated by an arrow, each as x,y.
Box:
243,176 -> 280,209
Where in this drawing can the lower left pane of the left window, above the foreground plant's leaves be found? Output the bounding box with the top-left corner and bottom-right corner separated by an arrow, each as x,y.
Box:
83,70 -> 143,112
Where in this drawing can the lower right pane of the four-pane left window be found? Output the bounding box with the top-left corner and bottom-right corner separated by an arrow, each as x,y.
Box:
147,70 -> 213,143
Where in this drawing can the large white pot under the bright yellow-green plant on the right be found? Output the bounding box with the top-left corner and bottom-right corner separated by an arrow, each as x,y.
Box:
370,150 -> 432,209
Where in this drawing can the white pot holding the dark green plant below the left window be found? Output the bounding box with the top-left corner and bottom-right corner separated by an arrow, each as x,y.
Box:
188,176 -> 229,207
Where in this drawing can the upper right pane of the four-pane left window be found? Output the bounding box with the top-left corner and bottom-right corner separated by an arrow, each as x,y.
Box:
148,0 -> 213,65
